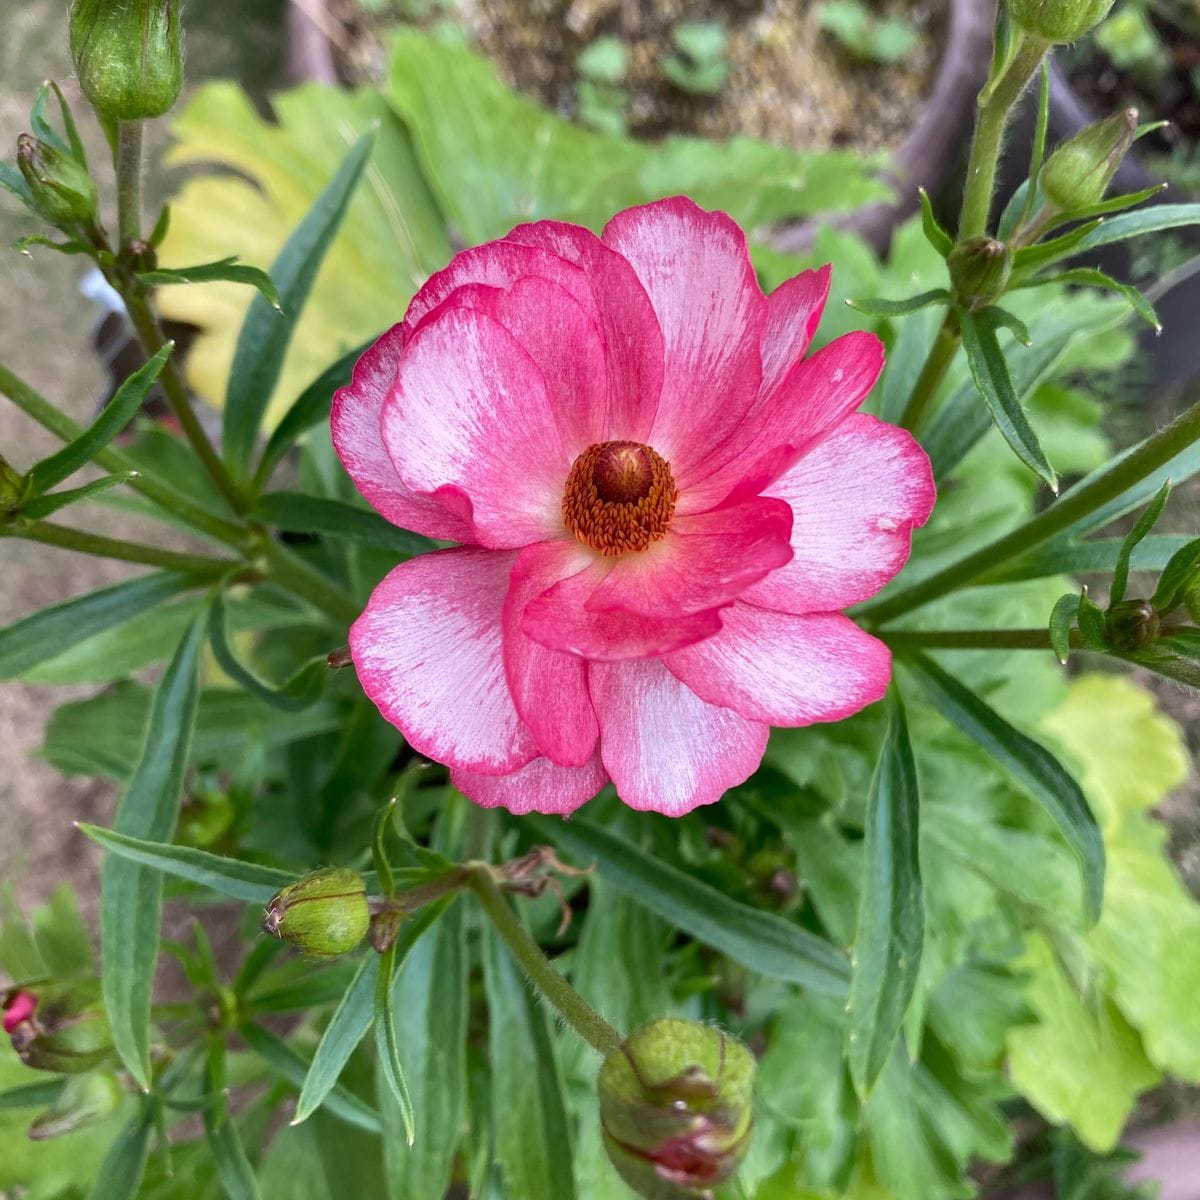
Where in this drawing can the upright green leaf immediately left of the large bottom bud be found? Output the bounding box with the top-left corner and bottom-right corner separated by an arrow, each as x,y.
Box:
484,921 -> 576,1200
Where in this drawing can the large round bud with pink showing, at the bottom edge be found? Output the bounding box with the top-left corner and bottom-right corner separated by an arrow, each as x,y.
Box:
598,1018 -> 755,1200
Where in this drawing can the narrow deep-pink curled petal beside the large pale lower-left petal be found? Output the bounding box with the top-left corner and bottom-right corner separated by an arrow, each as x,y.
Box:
504,542 -> 600,767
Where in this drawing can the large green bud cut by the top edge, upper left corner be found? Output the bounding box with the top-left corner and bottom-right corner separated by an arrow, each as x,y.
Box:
71,0 -> 184,121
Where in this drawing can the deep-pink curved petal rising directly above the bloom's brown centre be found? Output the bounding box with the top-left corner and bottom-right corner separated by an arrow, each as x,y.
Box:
506,221 -> 662,443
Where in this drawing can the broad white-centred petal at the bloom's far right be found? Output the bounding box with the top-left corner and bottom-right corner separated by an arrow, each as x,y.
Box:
743,413 -> 935,613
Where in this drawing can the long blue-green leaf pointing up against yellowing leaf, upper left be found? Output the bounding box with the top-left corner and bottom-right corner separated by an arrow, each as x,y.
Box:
222,133 -> 376,478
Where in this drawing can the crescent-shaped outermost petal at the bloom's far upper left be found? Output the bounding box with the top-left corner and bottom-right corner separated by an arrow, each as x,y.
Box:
331,325 -> 475,542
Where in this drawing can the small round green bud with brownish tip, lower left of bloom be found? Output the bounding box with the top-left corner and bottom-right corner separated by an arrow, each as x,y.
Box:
263,866 -> 371,959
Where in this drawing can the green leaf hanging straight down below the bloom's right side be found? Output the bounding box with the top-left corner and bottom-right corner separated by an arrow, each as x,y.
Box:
846,695 -> 925,1099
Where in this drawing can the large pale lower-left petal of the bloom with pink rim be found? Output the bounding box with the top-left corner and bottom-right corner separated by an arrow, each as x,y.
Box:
350,547 -> 538,774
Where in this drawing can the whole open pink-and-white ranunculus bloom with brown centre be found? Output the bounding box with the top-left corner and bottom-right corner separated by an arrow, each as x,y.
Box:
332,198 -> 934,815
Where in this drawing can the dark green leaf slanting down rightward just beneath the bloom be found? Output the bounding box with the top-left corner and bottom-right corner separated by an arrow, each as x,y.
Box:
526,814 -> 850,997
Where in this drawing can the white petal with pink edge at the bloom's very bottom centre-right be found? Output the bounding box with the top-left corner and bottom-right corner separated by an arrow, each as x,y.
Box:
588,661 -> 768,816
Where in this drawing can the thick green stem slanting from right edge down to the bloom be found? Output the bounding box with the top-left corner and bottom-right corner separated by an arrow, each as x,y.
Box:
858,403 -> 1200,625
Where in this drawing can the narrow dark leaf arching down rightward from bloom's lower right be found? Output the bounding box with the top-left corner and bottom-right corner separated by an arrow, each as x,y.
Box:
906,652 -> 1104,924
